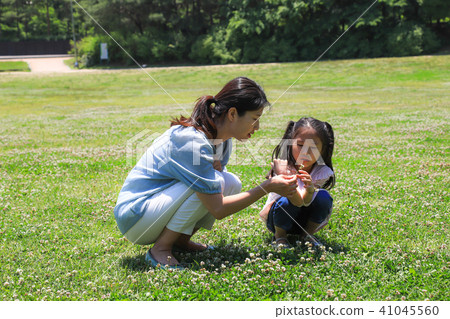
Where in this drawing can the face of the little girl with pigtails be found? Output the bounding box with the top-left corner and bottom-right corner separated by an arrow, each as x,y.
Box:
292,127 -> 323,173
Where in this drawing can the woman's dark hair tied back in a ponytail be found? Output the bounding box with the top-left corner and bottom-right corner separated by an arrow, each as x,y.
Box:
171,77 -> 270,139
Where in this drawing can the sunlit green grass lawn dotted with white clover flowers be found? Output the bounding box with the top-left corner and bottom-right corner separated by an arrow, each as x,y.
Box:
0,56 -> 450,300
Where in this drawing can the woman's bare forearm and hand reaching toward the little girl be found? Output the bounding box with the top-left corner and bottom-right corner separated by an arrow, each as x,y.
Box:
196,175 -> 297,219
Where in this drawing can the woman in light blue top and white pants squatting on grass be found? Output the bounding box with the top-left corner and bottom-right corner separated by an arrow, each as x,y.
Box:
114,77 -> 296,268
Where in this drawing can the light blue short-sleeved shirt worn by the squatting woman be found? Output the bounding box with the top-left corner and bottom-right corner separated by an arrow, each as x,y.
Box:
114,125 -> 232,234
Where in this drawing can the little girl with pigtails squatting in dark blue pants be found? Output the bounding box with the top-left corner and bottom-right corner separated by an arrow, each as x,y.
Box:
260,117 -> 335,247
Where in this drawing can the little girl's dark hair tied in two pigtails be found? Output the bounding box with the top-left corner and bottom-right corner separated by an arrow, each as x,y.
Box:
272,117 -> 336,189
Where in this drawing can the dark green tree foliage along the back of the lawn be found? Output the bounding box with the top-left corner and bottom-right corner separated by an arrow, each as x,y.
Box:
0,0 -> 450,65
